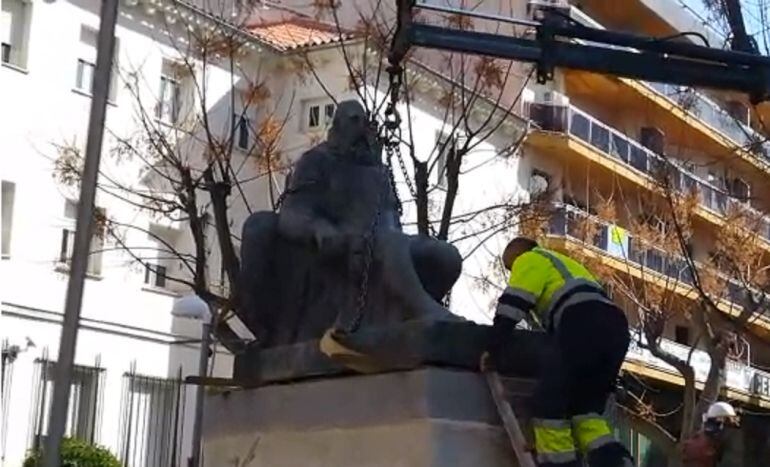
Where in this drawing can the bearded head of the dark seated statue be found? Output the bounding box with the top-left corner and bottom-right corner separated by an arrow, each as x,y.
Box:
326,100 -> 380,164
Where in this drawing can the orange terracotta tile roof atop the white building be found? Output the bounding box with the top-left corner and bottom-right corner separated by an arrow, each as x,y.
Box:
247,18 -> 352,51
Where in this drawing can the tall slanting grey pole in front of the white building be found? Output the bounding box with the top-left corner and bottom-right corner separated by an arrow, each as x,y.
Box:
43,0 -> 119,467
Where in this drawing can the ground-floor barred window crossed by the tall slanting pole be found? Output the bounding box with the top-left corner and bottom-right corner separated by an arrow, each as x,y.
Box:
32,360 -> 104,446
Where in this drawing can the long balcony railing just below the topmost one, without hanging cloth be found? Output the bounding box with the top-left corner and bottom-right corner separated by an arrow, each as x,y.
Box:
529,103 -> 770,240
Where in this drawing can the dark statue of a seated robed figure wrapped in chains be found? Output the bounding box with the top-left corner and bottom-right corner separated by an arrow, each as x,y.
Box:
238,101 -> 462,347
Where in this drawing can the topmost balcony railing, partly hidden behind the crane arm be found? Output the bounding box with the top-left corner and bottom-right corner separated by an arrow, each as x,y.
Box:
570,7 -> 770,162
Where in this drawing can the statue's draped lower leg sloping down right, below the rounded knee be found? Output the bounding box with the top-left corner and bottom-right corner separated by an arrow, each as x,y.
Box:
375,232 -> 452,319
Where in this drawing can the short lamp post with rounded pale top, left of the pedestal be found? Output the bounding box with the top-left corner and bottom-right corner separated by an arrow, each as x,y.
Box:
171,295 -> 214,467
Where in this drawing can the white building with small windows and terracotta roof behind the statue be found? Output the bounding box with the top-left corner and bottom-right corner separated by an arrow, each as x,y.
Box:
0,0 -> 521,467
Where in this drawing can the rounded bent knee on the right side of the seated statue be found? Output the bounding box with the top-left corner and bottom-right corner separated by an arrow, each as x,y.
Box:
410,236 -> 463,301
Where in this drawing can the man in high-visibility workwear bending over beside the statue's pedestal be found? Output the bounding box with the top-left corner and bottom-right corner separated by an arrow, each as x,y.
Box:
482,237 -> 632,467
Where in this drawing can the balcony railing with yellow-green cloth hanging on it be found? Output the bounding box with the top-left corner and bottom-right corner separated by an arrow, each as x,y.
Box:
548,204 -> 744,304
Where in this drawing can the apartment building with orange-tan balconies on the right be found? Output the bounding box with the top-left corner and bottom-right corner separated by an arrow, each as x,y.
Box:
516,0 -> 770,465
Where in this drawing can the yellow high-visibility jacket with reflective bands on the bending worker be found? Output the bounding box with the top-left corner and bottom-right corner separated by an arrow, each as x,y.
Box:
497,247 -> 612,330
